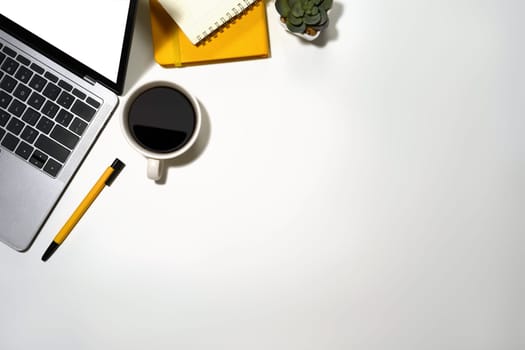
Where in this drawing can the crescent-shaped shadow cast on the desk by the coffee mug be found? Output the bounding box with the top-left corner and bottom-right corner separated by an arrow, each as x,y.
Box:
155,101 -> 211,185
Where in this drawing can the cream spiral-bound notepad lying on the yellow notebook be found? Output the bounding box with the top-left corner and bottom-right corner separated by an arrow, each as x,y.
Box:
159,0 -> 256,45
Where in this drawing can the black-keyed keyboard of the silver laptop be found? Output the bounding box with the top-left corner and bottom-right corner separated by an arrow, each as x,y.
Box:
0,43 -> 100,177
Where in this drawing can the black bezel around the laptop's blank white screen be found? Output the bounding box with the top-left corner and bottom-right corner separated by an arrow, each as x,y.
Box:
0,0 -> 138,95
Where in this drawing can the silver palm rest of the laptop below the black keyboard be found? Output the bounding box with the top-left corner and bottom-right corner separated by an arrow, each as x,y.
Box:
0,149 -> 65,251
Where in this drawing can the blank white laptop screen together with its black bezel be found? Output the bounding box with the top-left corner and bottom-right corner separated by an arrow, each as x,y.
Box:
0,0 -> 136,91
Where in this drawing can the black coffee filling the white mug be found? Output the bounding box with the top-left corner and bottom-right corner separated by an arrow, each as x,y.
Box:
128,86 -> 196,153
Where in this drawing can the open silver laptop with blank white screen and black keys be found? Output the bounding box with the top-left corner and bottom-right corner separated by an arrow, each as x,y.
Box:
0,0 -> 137,251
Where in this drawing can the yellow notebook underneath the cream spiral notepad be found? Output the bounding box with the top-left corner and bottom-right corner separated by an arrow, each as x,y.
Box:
150,0 -> 270,67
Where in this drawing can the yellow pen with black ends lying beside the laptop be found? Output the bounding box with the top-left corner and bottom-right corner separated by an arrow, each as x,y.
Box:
42,158 -> 126,261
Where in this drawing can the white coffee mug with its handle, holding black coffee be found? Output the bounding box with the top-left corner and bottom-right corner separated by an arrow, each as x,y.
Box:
121,81 -> 202,181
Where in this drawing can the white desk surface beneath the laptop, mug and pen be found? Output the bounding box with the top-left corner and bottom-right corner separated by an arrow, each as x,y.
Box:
0,0 -> 525,350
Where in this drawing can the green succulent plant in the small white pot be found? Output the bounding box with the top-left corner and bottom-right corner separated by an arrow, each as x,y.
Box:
275,0 -> 333,35
